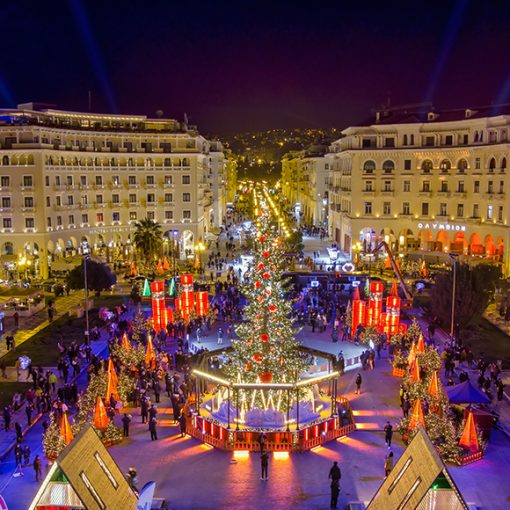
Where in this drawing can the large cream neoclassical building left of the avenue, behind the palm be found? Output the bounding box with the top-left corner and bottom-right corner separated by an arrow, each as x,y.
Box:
0,103 -> 232,277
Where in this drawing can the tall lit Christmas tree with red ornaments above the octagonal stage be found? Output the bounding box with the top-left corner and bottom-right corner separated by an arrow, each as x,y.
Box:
225,209 -> 309,409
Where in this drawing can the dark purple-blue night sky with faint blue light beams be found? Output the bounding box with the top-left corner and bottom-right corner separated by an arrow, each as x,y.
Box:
0,0 -> 510,134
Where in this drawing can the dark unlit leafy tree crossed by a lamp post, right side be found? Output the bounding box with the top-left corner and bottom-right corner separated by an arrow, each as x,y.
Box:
431,264 -> 501,327
